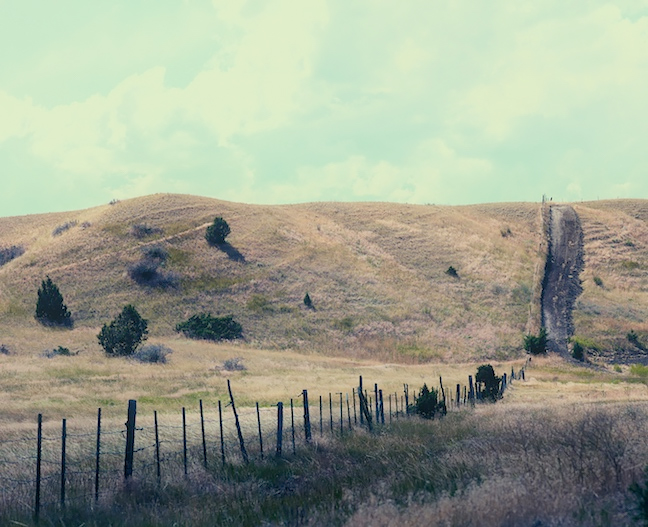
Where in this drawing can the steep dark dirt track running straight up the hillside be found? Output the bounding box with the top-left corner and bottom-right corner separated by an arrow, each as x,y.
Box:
541,205 -> 583,354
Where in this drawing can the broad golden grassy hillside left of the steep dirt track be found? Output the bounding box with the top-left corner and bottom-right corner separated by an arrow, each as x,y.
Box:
0,195 -> 540,361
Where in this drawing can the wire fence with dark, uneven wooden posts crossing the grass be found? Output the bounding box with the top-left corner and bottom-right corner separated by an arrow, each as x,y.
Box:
0,361 -> 528,521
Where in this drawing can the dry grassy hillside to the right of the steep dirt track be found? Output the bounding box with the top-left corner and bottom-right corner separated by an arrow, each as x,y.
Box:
574,200 -> 648,362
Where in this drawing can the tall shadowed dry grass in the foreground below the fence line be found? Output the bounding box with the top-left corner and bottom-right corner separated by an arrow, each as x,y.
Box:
5,403 -> 648,527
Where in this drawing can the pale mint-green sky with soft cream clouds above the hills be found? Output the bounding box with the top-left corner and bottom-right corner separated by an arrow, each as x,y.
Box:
0,0 -> 648,216
